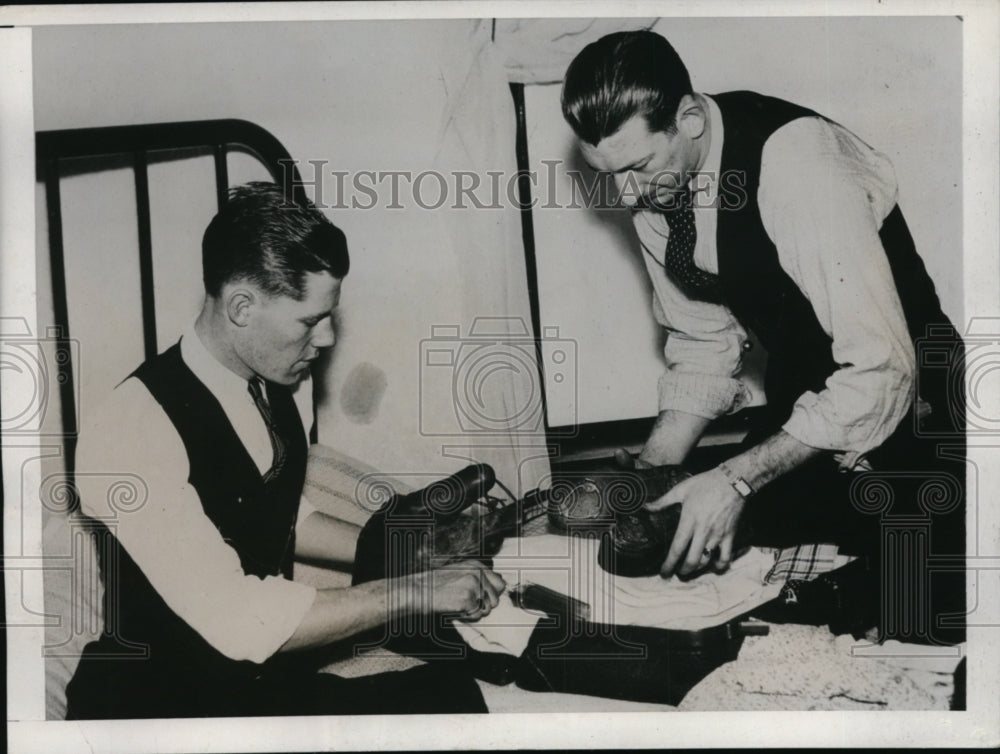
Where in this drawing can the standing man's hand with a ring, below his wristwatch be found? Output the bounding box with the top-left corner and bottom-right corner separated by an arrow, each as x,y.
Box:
646,469 -> 744,578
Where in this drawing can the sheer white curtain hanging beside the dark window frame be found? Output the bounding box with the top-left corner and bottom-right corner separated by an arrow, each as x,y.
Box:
424,19 -> 656,494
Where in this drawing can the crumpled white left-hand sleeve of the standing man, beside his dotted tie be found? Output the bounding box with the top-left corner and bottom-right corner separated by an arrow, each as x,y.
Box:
634,212 -> 751,419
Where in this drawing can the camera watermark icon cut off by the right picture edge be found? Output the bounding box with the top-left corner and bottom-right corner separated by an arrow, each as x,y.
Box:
914,317 -> 1000,438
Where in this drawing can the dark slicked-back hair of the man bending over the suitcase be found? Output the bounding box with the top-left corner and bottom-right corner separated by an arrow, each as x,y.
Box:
562,31 -> 694,146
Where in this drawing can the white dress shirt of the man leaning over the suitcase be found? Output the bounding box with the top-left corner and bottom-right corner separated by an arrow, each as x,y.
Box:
633,96 -> 915,458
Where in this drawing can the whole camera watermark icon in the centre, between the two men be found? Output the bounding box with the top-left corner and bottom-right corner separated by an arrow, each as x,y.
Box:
420,317 -> 577,437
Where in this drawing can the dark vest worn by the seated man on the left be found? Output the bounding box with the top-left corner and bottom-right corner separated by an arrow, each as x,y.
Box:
94,344 -> 307,690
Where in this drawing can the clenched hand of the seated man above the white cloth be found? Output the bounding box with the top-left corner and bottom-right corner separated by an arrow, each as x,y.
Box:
402,560 -> 507,621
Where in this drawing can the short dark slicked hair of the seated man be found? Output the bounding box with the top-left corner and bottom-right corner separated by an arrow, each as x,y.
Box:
201,181 -> 350,301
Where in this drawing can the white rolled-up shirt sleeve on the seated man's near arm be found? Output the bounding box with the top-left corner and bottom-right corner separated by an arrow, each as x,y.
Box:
77,378 -> 316,663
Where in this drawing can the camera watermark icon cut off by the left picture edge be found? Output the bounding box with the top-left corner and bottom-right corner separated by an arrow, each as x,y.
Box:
0,317 -> 80,436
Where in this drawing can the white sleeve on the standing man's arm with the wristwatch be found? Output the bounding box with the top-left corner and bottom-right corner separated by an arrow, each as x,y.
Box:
758,118 -> 915,458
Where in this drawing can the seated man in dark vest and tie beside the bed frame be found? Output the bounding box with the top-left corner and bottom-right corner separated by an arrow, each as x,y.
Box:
67,183 -> 504,719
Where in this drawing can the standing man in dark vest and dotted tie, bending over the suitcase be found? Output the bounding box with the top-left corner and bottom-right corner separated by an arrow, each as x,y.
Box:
562,32 -> 965,640
